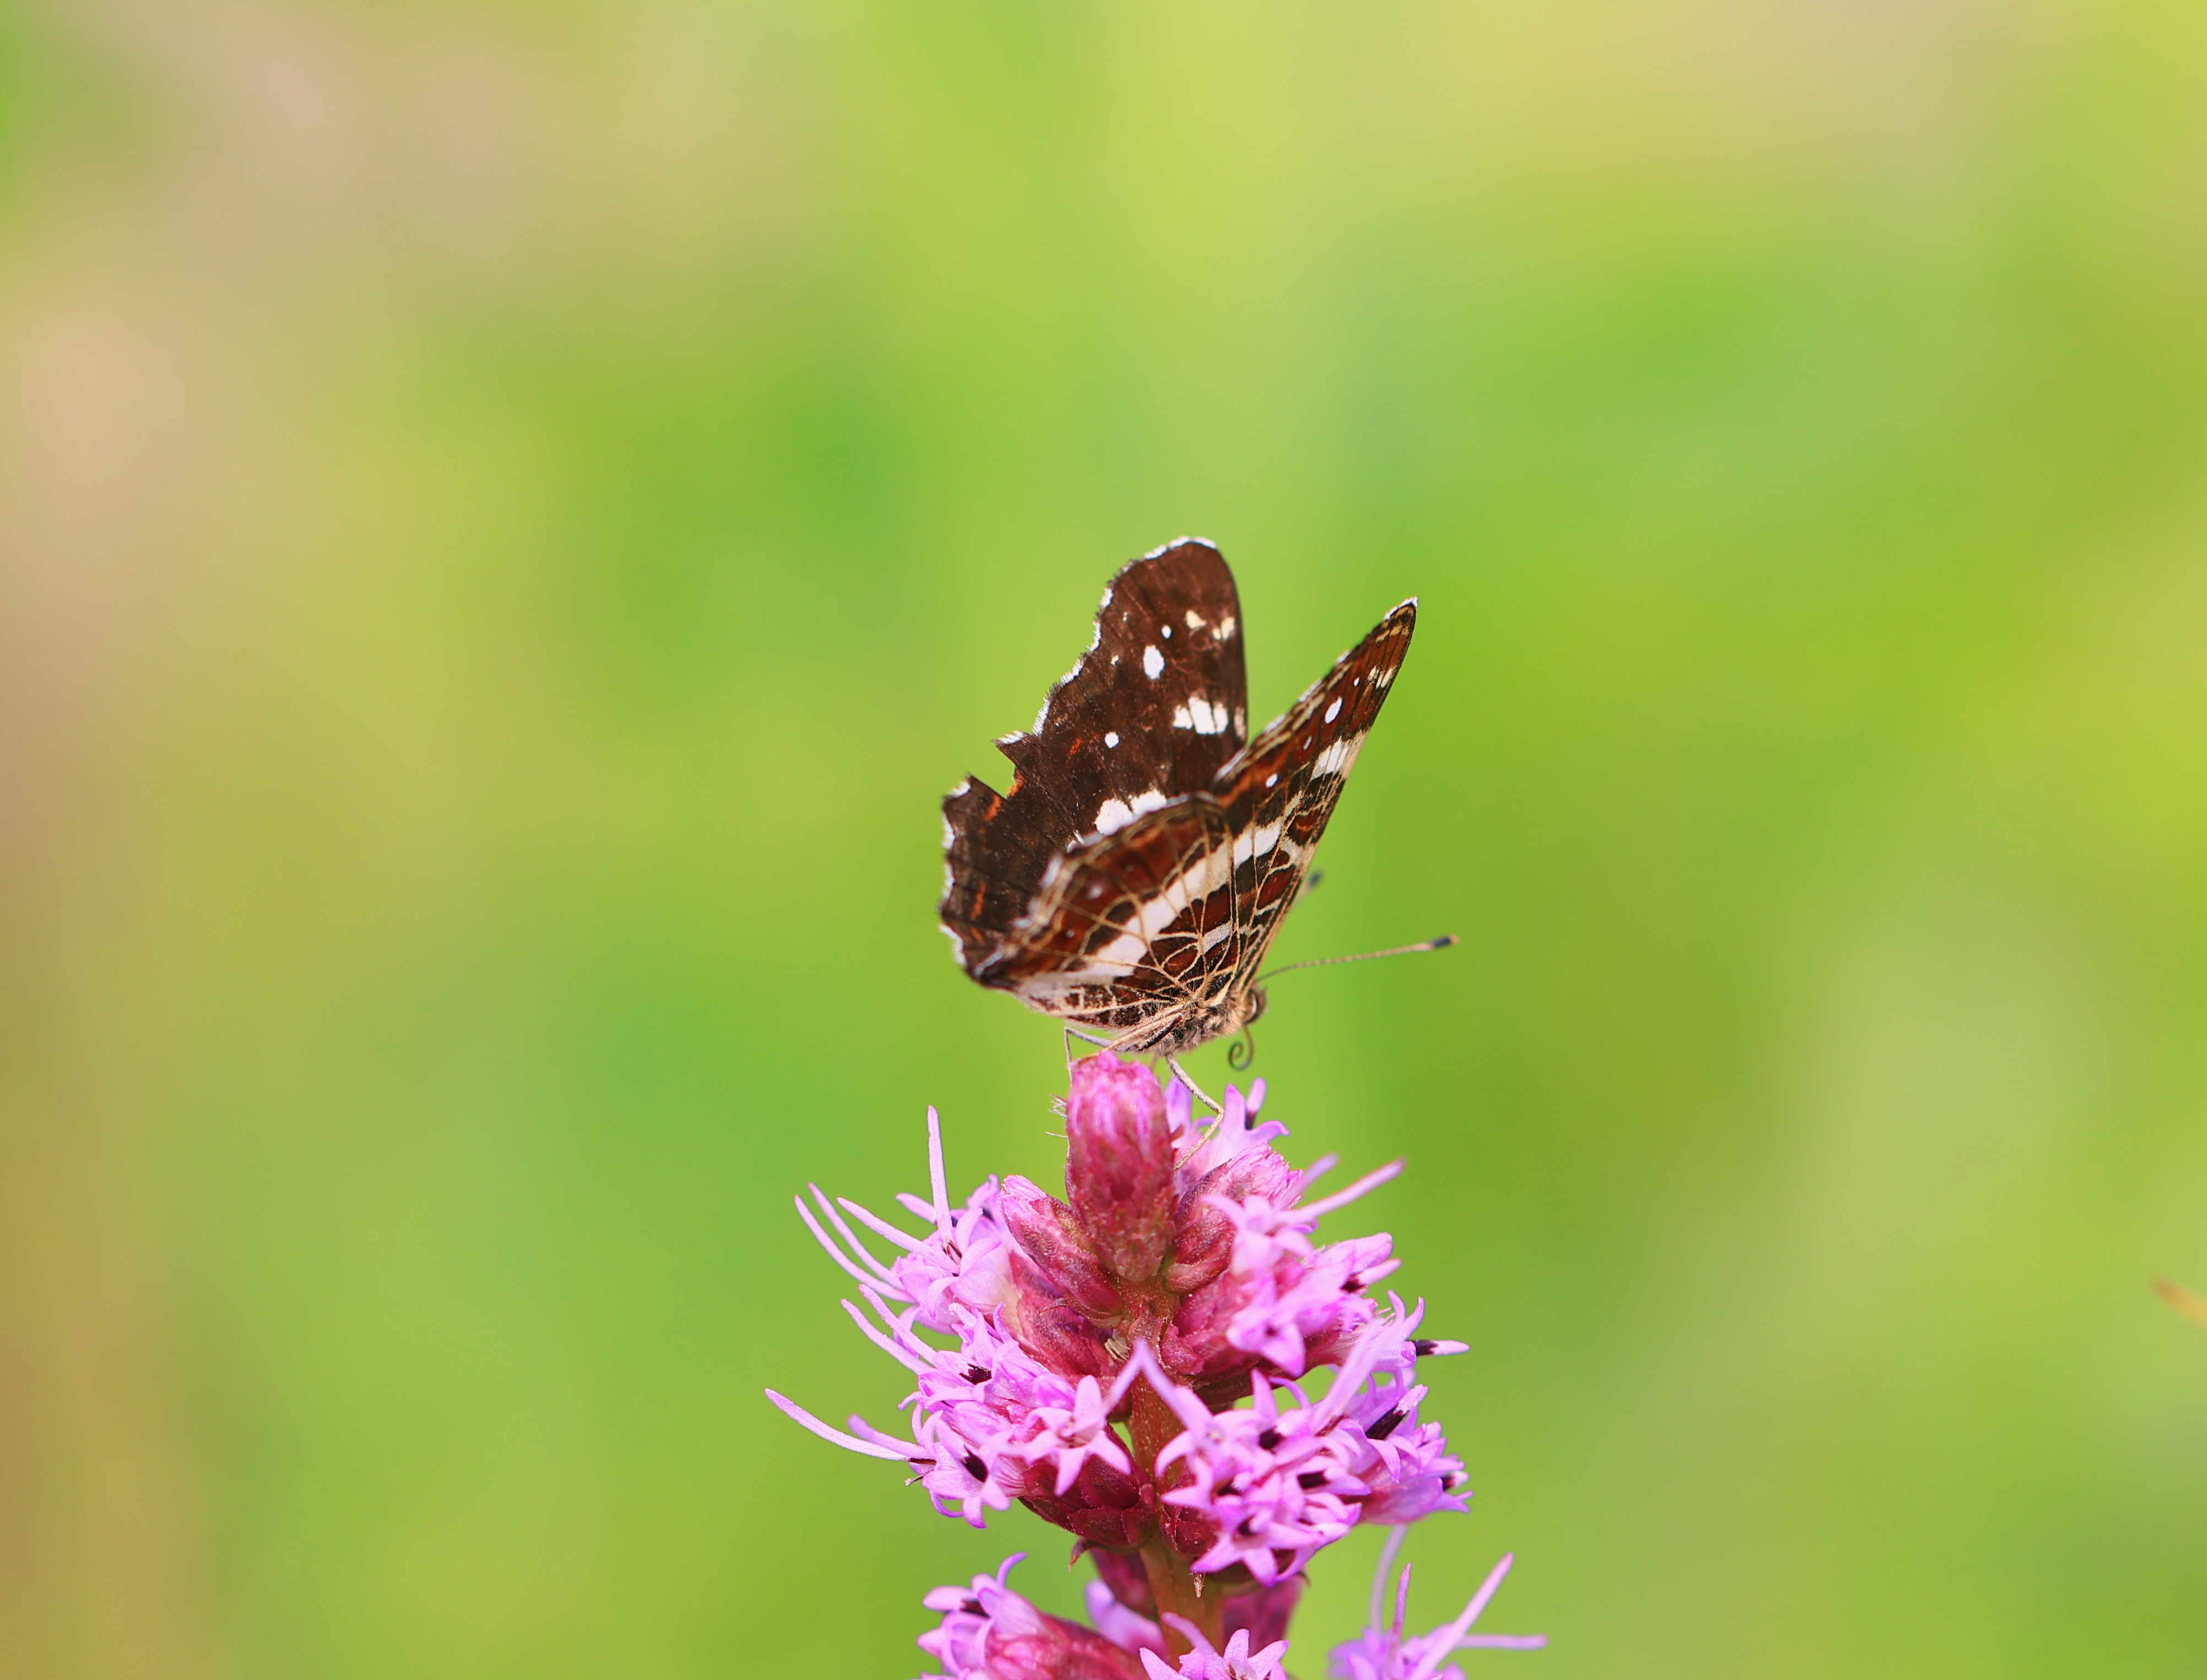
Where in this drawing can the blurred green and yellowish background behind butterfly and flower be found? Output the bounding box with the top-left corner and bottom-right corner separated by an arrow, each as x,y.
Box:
0,0 -> 2207,1680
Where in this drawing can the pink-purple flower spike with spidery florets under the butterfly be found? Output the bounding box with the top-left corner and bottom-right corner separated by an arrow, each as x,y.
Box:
768,1053 -> 1536,1680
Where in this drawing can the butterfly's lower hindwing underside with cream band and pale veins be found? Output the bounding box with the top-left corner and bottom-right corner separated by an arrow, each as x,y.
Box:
971,792 -> 1238,1029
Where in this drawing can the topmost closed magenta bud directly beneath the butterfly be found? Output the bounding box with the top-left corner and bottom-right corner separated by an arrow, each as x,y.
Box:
1066,1051 -> 1172,1282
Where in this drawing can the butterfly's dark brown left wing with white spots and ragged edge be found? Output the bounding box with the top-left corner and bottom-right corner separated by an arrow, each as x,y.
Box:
942,539 -> 1249,978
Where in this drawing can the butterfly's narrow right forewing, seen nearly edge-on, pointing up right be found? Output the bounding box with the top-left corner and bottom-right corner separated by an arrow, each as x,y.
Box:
1216,601 -> 1417,989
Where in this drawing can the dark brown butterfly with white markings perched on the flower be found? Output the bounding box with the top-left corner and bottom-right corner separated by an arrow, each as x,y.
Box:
940,536 -> 1446,1057
